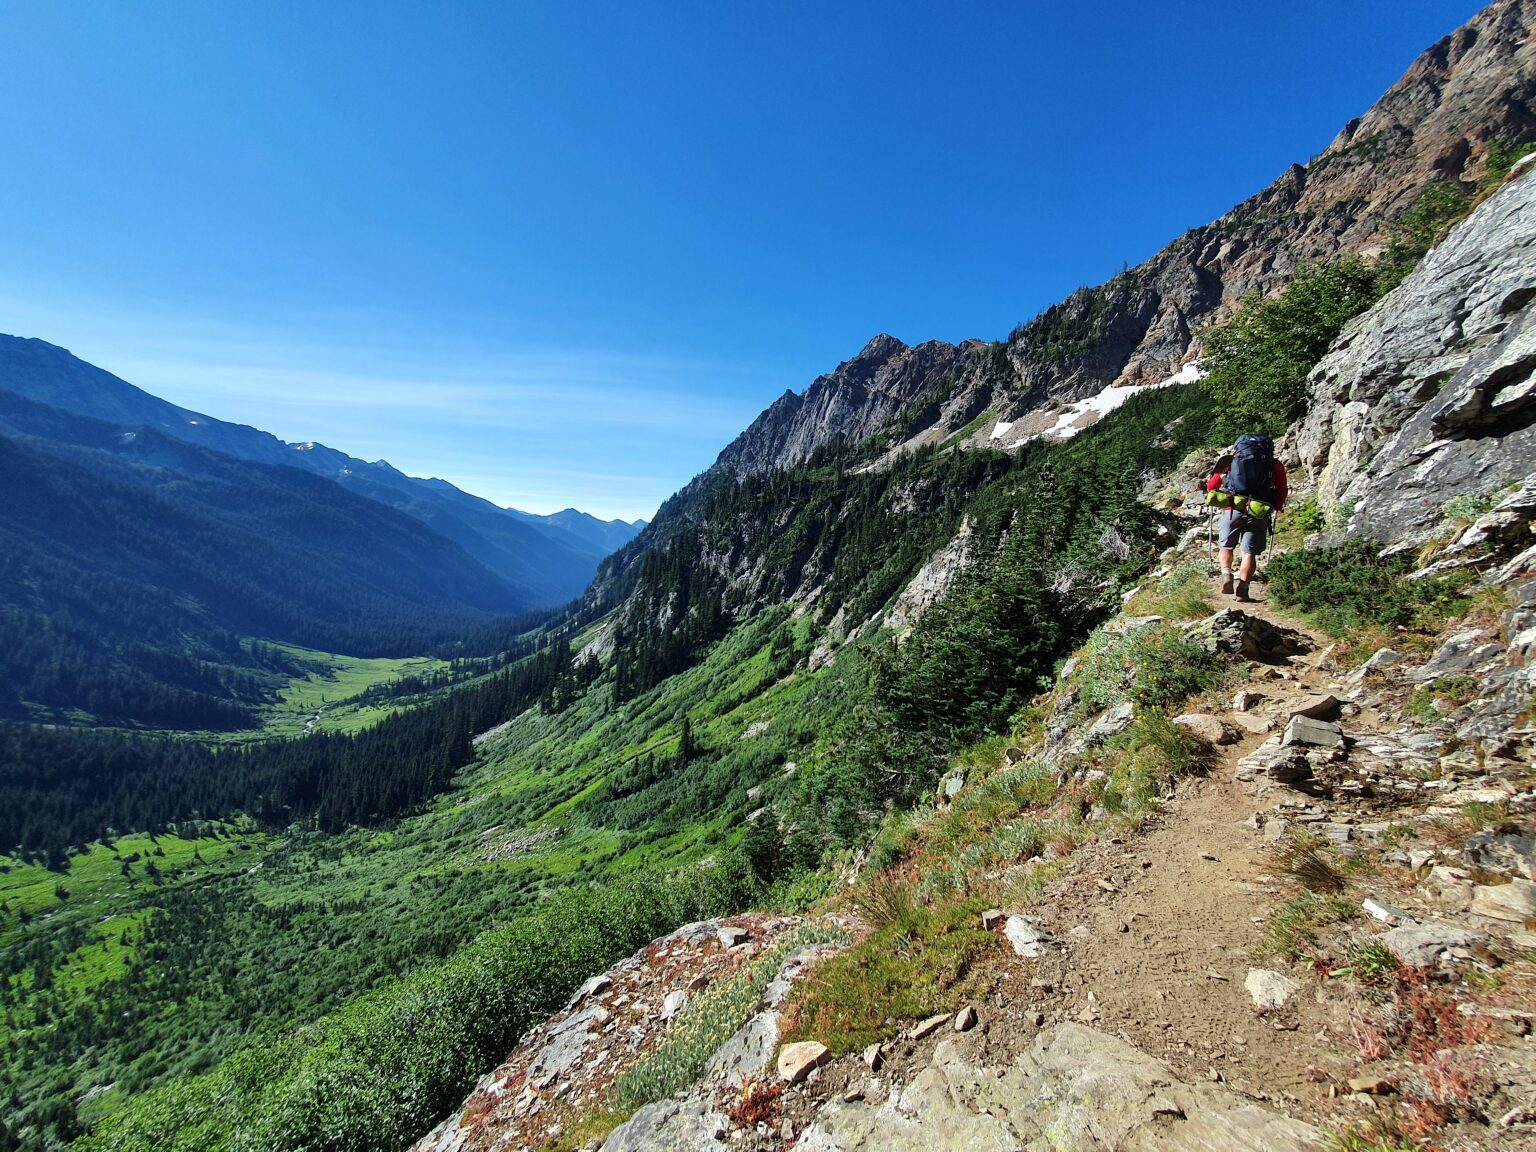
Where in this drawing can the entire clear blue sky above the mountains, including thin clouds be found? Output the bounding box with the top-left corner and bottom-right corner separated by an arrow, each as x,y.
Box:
0,0 -> 1479,518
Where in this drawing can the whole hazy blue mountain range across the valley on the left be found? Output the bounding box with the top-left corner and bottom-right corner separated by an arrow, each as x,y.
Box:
0,336 -> 644,728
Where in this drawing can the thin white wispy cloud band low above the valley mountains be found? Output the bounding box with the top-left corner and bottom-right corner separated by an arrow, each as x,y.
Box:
0,292 -> 785,519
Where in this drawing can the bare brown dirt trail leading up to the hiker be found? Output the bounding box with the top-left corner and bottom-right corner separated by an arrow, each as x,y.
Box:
1007,586 -> 1376,1101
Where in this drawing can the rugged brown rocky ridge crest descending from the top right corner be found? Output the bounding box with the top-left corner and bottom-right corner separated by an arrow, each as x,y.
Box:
707,0 -> 1536,478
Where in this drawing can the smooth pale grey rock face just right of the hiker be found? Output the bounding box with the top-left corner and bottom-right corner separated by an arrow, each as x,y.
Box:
1296,164 -> 1536,548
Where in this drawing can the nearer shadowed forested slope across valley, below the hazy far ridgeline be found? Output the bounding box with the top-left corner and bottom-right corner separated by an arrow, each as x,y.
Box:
0,393 -> 546,728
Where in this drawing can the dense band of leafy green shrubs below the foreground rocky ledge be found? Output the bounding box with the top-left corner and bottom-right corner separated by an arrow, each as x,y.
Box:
78,862 -> 751,1152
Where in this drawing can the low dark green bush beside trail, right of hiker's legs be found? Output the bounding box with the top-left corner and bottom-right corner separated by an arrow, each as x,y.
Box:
1267,538 -> 1470,636
